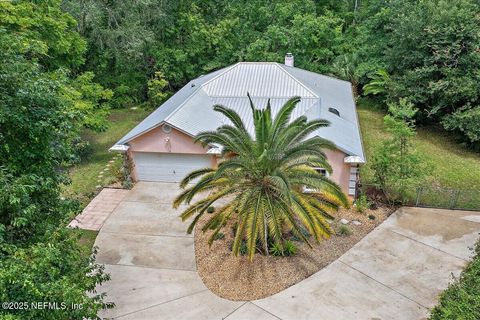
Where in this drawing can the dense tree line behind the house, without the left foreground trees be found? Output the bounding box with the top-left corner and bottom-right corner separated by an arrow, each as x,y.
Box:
63,0 -> 480,146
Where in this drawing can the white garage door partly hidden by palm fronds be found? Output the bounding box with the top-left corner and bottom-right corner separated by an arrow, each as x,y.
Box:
133,152 -> 212,182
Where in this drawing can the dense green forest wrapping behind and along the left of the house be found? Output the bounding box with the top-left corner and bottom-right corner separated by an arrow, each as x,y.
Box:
0,0 -> 480,319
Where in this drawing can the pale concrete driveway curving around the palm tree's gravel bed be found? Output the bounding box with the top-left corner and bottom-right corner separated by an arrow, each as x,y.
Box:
96,182 -> 480,320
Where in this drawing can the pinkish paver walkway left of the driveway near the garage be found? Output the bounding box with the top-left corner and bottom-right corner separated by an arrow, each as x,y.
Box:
68,188 -> 129,231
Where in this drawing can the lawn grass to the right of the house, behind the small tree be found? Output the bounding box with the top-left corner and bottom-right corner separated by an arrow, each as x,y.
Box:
358,99 -> 480,207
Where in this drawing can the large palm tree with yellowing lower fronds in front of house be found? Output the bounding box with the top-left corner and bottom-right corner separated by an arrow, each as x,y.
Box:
174,95 -> 348,260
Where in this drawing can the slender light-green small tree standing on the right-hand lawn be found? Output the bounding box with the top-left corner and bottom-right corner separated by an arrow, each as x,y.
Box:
372,99 -> 429,202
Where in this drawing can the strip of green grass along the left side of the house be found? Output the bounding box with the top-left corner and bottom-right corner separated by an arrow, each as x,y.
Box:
63,109 -> 149,205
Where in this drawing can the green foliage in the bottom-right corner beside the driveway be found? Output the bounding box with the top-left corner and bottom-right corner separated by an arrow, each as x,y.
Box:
430,241 -> 480,320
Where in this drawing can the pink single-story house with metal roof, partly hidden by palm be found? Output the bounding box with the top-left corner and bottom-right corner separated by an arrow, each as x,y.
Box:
110,55 -> 365,196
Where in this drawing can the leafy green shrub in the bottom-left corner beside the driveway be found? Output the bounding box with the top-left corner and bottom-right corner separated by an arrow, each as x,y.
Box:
0,227 -> 113,320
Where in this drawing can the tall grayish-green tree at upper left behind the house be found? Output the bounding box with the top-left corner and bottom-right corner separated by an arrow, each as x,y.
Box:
62,0 -> 174,108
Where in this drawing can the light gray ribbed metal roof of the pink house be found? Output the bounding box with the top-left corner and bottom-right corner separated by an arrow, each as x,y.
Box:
117,62 -> 365,160
